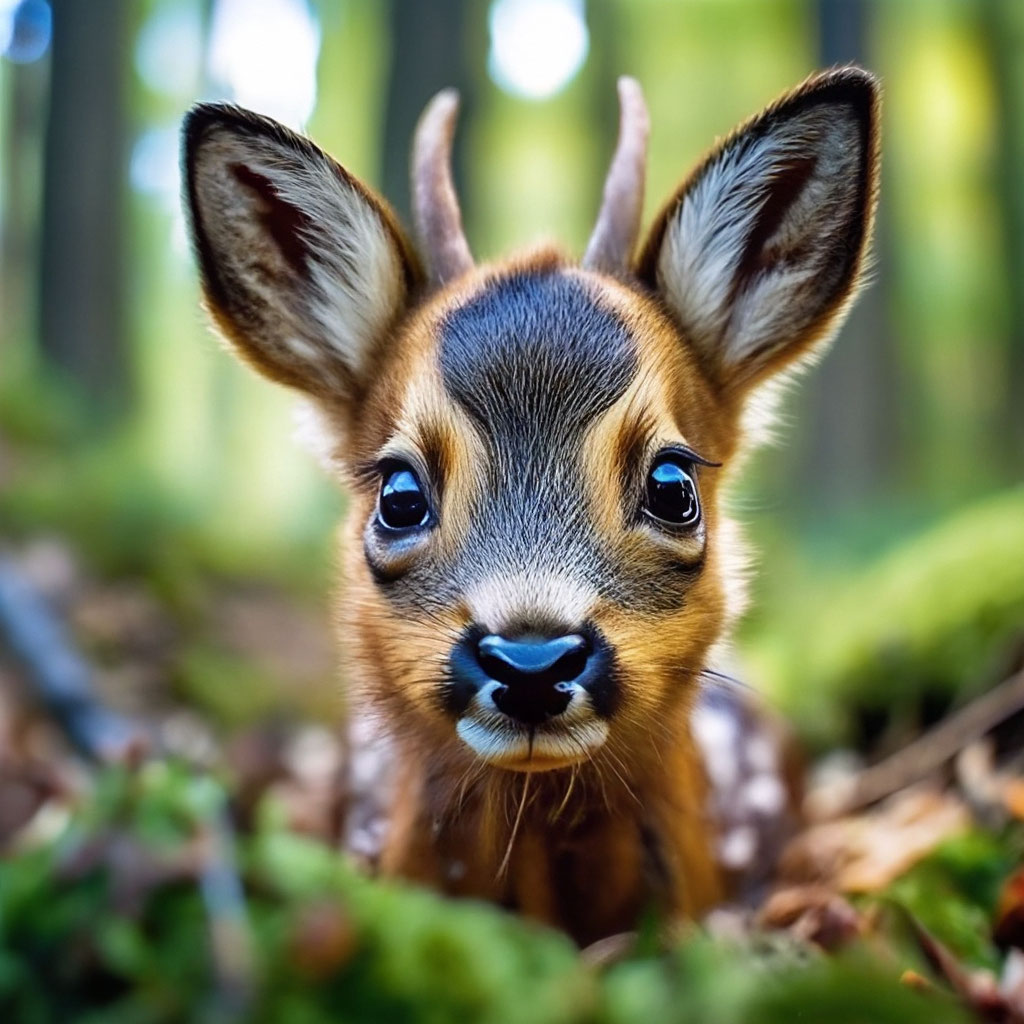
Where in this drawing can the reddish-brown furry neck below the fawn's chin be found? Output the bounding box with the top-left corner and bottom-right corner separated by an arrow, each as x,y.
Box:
382,712 -> 718,944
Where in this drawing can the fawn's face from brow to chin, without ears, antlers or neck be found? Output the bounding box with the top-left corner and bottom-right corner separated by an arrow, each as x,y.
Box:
349,264 -> 731,768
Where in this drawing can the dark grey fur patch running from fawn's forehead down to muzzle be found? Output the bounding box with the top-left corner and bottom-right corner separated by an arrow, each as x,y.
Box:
439,269 -> 637,625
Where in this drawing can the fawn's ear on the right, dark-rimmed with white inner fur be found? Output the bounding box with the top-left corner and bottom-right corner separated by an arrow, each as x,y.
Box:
638,68 -> 879,392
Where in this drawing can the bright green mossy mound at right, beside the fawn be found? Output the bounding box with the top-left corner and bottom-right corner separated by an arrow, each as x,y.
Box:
752,488 -> 1024,745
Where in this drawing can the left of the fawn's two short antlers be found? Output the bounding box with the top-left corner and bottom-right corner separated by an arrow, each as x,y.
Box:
413,89 -> 473,286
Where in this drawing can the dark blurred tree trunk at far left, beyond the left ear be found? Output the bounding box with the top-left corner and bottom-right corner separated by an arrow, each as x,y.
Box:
39,0 -> 129,414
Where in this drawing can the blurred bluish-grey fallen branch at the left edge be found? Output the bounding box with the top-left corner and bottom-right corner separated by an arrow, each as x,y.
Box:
0,557 -> 148,761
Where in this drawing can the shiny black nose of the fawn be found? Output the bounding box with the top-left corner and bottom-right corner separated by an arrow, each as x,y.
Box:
476,634 -> 593,725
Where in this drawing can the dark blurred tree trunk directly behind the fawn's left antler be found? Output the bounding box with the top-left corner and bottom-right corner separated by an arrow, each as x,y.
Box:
381,0 -> 473,242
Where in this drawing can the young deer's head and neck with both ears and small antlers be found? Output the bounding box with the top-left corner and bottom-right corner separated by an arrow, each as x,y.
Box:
184,68 -> 879,943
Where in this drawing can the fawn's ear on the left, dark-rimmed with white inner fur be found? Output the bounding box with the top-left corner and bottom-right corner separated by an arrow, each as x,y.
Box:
182,103 -> 420,402
